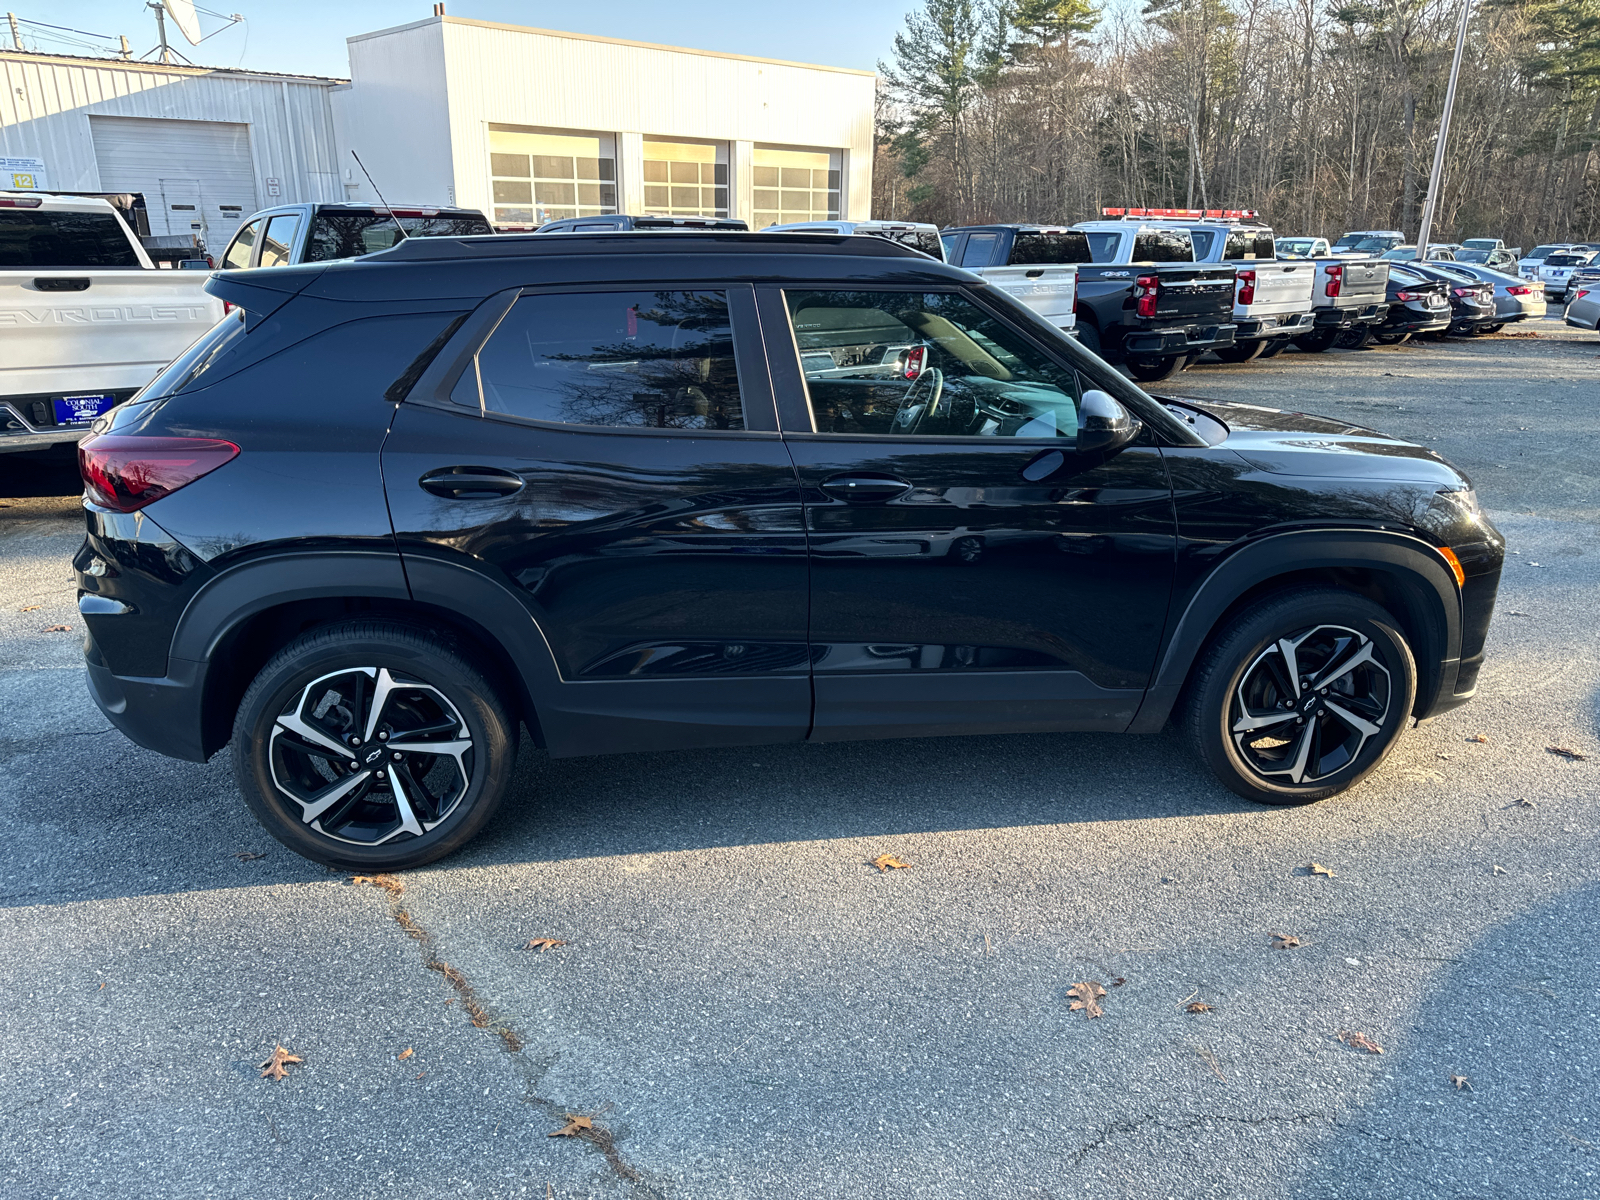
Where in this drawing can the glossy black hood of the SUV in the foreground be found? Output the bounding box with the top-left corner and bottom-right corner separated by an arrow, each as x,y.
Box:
1173,397 -> 1469,488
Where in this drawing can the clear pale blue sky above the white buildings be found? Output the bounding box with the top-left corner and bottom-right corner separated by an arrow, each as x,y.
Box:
34,0 -> 915,75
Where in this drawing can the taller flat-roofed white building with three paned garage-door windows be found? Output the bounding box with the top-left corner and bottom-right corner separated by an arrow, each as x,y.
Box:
333,16 -> 875,229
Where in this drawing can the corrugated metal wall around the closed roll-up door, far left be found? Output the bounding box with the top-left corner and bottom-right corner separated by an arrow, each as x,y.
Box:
0,51 -> 344,205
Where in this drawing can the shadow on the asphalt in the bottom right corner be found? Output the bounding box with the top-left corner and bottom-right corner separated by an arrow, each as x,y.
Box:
1285,883 -> 1600,1200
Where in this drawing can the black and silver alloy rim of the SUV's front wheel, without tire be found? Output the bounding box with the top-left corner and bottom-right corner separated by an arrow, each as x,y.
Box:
1229,626 -> 1392,784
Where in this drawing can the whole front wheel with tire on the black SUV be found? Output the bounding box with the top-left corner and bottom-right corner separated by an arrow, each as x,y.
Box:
1182,587 -> 1416,805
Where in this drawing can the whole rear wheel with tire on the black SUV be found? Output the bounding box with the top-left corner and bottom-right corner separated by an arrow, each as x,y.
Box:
234,621 -> 517,870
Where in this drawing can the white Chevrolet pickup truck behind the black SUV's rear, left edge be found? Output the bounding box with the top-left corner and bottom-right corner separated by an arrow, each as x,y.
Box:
0,192 -> 222,453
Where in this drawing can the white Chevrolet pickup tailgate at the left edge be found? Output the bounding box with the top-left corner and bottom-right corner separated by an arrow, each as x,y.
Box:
0,267 -> 222,395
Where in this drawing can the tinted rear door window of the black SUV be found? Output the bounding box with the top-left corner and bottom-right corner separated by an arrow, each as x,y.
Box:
453,290 -> 744,430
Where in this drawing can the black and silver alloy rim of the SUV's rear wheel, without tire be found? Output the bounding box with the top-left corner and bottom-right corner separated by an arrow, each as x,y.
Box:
267,667 -> 472,846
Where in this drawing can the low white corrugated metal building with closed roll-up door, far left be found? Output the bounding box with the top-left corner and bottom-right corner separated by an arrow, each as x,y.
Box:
0,50 -> 344,251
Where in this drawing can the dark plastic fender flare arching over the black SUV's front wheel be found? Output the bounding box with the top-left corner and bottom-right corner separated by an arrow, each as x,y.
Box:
1128,530 -> 1461,733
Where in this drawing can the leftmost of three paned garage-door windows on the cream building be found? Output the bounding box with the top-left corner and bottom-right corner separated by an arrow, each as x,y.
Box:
490,125 -> 616,226
